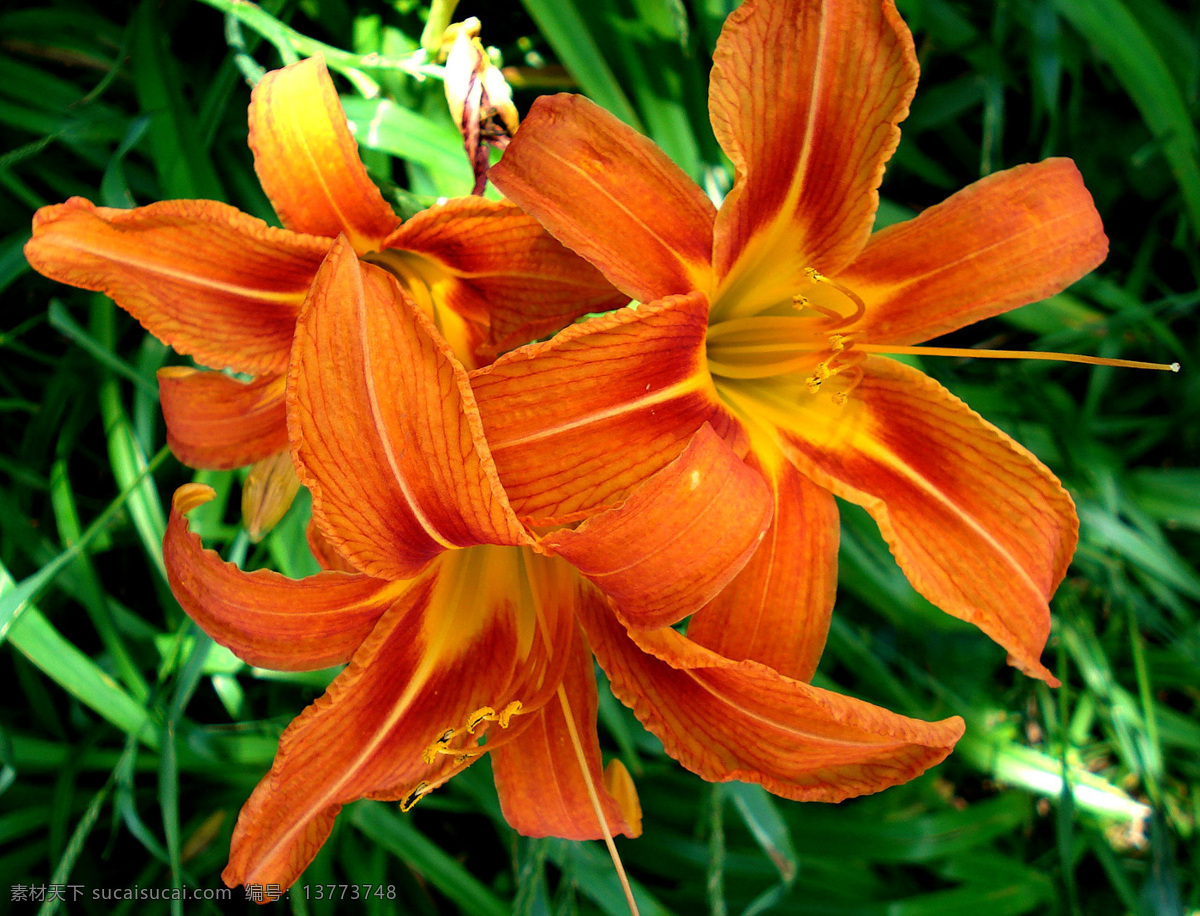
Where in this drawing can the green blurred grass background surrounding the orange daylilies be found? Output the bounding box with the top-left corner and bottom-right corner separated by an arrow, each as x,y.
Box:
0,0 -> 1200,916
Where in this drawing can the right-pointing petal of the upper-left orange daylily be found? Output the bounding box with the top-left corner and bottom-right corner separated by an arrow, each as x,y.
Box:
388,197 -> 629,358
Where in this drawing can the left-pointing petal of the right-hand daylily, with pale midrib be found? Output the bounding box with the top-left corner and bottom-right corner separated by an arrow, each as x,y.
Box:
470,294 -> 745,519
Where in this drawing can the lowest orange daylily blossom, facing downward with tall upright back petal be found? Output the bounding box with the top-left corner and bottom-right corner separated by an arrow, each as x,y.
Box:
163,239 -> 921,887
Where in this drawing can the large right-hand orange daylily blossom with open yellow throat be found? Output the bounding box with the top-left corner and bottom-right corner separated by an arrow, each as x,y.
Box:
472,0 -> 1108,768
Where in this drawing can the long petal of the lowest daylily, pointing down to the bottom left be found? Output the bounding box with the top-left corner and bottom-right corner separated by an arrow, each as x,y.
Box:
223,546 -> 574,887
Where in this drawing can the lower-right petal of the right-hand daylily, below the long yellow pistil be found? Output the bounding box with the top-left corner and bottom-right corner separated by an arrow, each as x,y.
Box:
785,357 -> 1079,685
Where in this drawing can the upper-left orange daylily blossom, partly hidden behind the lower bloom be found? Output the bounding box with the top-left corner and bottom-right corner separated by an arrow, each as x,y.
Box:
25,58 -> 628,537
